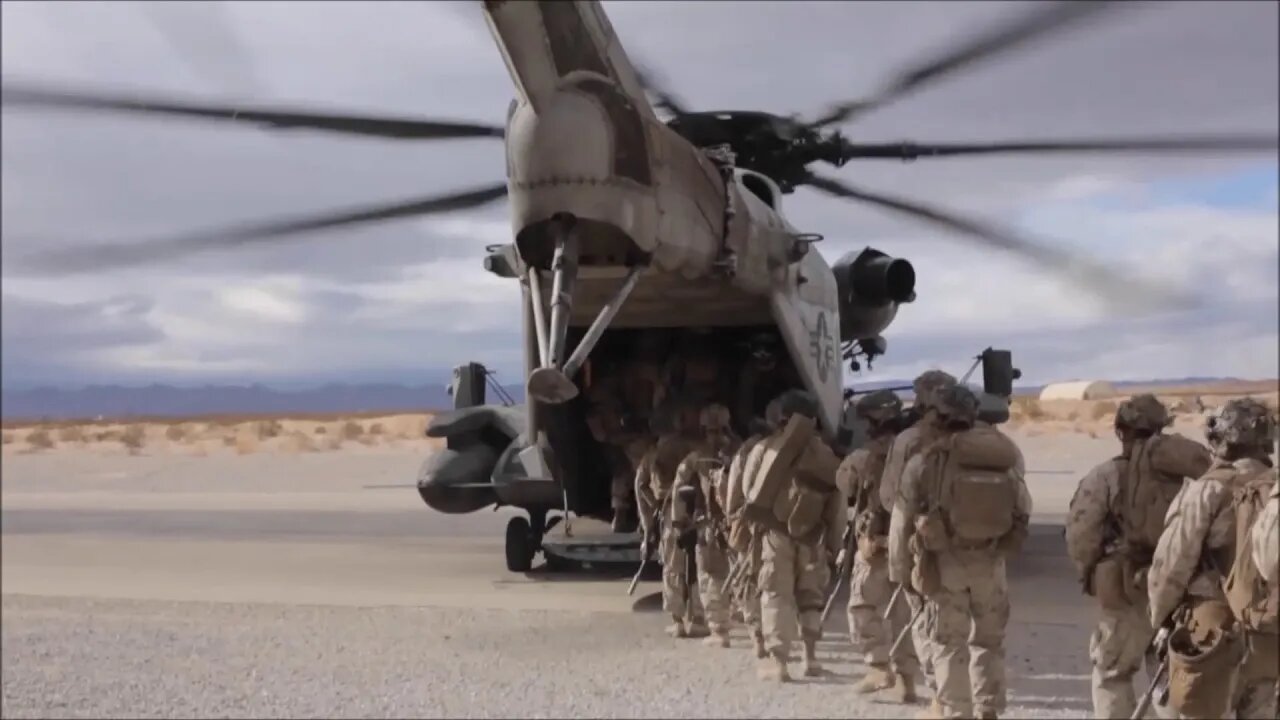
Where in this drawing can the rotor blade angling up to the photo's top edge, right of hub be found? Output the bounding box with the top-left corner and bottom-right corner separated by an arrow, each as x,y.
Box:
809,0 -> 1120,128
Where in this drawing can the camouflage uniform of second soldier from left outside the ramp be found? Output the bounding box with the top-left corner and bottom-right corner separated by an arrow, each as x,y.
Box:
672,405 -> 739,647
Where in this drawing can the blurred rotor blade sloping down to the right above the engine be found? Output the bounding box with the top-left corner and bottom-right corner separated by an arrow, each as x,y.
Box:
805,174 -> 1194,311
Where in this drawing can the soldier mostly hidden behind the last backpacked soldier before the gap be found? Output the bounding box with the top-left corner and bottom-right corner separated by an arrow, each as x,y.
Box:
879,370 -> 956,712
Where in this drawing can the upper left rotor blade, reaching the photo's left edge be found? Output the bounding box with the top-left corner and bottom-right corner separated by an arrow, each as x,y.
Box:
0,83 -> 504,140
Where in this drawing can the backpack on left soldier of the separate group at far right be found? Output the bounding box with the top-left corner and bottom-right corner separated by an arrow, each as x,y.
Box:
1119,436 -> 1213,557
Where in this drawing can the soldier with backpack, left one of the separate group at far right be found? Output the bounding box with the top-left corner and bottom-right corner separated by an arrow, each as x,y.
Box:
1066,395 -> 1211,717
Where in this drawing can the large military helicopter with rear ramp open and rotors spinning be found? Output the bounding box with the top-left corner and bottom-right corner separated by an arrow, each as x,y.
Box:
4,0 -> 1277,571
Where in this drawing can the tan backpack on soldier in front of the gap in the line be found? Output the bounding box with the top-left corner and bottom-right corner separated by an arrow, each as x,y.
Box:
937,427 -> 1018,543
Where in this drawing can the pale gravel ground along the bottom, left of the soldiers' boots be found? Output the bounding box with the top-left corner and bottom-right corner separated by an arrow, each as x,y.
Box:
3,596 -> 1088,717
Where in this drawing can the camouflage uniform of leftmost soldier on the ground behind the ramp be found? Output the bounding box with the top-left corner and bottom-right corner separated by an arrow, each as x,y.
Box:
635,399 -> 708,638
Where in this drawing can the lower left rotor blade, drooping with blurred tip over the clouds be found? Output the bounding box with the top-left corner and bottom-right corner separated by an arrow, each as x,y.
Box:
12,183 -> 507,274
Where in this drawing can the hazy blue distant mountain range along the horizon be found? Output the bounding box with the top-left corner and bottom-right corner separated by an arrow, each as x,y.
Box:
0,378 -> 1259,420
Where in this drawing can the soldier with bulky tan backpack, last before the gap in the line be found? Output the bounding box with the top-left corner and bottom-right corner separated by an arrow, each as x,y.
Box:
888,386 -> 1032,719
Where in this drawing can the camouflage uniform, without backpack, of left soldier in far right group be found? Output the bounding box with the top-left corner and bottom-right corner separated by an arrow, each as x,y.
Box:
1065,395 -> 1208,717
